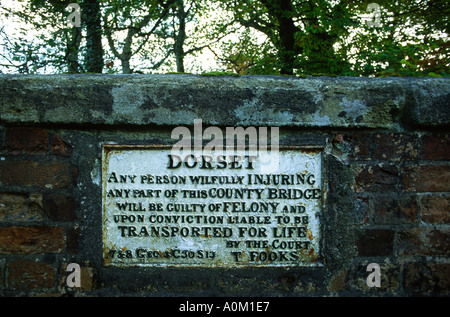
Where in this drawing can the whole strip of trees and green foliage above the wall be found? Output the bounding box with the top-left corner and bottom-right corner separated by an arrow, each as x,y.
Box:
0,0 -> 450,77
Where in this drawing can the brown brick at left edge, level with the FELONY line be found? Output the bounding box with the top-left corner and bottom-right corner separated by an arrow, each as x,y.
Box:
0,193 -> 43,221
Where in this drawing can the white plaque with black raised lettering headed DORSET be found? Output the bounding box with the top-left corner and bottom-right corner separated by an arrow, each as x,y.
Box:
102,145 -> 325,267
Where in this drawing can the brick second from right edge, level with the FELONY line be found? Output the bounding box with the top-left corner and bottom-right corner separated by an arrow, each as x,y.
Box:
372,195 -> 418,225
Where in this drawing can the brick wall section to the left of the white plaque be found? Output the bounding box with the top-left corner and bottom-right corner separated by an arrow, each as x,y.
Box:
0,127 -> 90,295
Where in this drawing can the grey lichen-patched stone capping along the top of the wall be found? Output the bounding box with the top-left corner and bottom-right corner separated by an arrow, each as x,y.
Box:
0,74 -> 450,128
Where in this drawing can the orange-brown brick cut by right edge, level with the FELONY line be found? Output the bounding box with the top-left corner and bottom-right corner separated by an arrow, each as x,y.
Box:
420,195 -> 450,224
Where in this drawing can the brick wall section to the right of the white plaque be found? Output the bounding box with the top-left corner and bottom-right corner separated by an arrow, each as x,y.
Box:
332,131 -> 450,296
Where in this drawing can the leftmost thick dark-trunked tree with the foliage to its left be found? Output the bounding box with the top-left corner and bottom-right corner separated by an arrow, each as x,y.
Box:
0,0 -> 103,73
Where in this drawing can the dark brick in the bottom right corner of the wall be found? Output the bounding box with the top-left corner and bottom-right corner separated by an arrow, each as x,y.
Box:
403,263 -> 450,296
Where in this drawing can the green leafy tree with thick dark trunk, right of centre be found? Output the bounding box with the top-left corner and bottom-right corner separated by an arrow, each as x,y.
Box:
223,0 -> 352,75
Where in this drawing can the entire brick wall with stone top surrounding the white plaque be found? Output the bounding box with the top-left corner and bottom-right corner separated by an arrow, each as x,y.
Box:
0,76 -> 450,296
